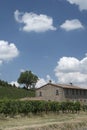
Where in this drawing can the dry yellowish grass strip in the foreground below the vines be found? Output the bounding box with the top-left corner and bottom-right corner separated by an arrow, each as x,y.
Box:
0,112 -> 87,130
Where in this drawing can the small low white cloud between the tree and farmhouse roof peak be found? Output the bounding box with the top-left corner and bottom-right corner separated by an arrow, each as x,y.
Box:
35,75 -> 55,88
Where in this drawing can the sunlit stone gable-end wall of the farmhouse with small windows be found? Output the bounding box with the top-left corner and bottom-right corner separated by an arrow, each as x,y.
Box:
36,84 -> 64,101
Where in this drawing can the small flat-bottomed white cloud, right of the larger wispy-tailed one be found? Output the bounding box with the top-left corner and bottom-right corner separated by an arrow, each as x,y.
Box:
60,19 -> 84,31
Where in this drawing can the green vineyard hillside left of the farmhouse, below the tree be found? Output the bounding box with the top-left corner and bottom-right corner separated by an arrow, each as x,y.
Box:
0,85 -> 35,99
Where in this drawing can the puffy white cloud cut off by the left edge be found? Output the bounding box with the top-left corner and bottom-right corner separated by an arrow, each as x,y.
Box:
0,40 -> 19,64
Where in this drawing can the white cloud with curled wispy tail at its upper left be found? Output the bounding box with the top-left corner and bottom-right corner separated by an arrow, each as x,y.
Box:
14,10 -> 56,32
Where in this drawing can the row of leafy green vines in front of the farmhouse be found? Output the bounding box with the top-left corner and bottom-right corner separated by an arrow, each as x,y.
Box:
0,100 -> 82,116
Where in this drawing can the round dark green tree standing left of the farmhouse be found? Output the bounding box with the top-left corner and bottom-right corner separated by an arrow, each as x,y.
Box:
18,71 -> 38,89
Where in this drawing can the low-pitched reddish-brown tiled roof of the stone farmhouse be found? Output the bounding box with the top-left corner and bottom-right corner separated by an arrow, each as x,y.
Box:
37,83 -> 87,90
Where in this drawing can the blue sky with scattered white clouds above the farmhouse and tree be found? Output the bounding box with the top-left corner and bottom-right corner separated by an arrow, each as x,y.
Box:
0,0 -> 87,87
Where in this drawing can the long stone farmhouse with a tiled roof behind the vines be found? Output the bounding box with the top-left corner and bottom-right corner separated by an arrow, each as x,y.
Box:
36,82 -> 87,103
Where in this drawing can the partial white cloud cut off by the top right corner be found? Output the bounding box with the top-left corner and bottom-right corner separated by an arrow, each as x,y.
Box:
67,0 -> 87,11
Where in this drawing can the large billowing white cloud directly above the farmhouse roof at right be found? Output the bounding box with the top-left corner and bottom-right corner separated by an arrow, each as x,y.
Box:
55,57 -> 87,87
